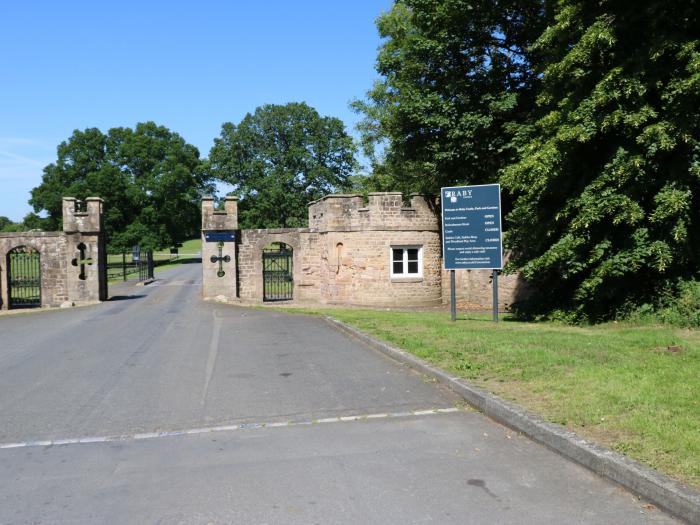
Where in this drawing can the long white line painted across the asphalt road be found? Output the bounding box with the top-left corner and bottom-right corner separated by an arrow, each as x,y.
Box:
0,407 -> 461,449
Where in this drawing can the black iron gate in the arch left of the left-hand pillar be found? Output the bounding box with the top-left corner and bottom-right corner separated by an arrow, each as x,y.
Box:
7,246 -> 41,308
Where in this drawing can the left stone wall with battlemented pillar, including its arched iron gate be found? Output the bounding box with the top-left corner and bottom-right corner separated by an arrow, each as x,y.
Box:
0,197 -> 107,309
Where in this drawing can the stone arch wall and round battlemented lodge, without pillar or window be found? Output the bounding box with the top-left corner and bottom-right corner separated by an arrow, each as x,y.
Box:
231,193 -> 441,306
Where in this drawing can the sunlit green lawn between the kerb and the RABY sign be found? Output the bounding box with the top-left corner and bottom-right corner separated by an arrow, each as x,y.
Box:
285,309 -> 700,487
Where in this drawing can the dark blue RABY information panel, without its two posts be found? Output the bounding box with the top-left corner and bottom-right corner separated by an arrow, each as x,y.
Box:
440,184 -> 503,270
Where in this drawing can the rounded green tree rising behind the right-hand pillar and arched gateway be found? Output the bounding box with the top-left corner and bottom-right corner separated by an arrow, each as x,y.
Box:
209,102 -> 356,228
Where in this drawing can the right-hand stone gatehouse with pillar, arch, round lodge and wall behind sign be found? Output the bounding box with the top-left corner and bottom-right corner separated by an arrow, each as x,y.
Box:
202,192 -> 519,309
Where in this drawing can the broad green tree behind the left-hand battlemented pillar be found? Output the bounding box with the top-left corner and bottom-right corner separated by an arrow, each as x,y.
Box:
30,122 -> 212,249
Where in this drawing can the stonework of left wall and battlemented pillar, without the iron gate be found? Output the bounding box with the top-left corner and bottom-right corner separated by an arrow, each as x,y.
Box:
0,197 -> 107,309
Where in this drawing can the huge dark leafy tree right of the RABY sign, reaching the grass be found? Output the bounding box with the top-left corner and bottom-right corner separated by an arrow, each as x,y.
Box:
503,0 -> 700,320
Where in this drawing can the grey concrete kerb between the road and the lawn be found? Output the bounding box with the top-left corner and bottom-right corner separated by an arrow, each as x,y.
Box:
324,317 -> 700,524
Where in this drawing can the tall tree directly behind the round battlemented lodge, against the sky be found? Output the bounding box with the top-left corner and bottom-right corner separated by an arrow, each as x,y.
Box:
353,0 -> 546,193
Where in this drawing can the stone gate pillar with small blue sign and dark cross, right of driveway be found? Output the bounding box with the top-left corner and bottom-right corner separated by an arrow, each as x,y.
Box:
202,197 -> 238,302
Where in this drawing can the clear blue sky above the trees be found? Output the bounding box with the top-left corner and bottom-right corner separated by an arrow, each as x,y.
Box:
0,0 -> 392,220
